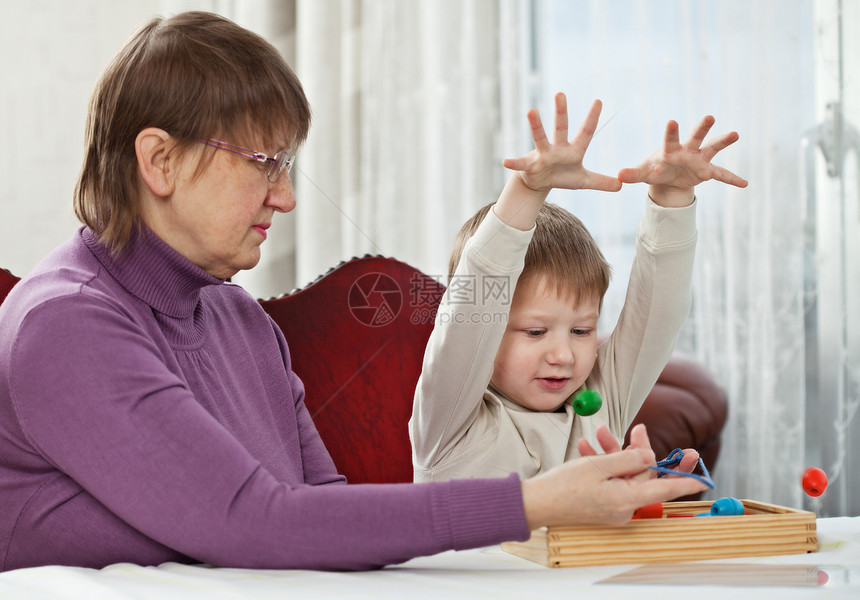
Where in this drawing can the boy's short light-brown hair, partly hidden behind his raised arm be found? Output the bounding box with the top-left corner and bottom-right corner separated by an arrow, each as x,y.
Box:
448,202 -> 612,307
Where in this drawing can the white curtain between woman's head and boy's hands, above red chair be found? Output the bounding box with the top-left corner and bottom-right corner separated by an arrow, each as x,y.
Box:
294,0 -> 525,285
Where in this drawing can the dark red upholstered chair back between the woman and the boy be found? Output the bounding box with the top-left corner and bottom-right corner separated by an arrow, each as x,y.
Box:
261,257 -> 444,483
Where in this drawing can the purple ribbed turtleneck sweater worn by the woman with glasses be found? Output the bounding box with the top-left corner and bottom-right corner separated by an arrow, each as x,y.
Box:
0,228 -> 528,570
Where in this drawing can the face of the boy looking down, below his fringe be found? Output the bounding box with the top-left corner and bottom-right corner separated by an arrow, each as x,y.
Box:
492,276 -> 600,411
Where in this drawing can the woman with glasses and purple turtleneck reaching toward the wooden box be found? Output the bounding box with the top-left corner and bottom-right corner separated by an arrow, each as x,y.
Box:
0,13 -> 703,570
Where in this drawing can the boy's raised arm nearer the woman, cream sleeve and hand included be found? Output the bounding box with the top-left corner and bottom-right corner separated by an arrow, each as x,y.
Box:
409,94 -> 621,469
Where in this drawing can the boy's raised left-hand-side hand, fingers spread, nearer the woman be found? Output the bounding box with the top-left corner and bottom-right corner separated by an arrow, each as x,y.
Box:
502,93 -> 621,192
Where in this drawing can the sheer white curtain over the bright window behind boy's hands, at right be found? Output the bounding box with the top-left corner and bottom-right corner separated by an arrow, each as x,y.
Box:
535,0 -> 860,514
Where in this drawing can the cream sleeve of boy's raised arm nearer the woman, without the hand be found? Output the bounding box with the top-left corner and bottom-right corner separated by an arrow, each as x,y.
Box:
409,211 -> 532,477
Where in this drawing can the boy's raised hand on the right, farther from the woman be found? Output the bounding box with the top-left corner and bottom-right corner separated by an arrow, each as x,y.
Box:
618,115 -> 747,206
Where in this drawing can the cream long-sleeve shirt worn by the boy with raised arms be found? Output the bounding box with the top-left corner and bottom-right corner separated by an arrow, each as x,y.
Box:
409,199 -> 696,482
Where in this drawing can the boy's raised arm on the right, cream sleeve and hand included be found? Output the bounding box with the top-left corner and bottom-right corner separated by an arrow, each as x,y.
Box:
599,116 -> 747,435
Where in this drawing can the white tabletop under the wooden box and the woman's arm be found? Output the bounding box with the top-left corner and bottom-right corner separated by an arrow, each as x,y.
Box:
0,517 -> 860,600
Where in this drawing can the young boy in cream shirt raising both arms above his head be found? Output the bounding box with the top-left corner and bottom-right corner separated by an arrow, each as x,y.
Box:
409,94 -> 747,481
